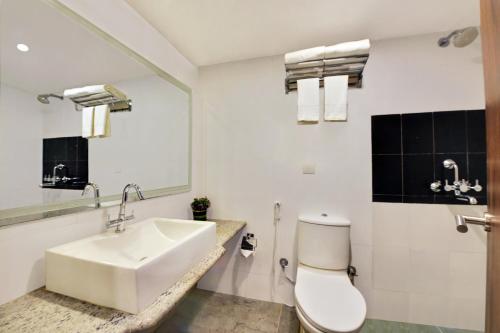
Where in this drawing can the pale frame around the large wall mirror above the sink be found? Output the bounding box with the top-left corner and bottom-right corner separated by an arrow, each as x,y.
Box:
0,0 -> 193,228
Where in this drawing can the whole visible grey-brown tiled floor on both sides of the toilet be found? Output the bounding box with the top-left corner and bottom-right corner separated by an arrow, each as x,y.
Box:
156,289 -> 478,333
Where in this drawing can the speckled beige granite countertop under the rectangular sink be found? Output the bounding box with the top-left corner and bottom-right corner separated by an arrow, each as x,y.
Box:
0,220 -> 246,333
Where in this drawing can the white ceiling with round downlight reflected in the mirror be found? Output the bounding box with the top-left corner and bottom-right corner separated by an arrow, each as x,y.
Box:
0,0 -> 153,94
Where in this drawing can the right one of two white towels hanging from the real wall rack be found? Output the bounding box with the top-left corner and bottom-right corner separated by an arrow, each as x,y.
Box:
324,75 -> 349,121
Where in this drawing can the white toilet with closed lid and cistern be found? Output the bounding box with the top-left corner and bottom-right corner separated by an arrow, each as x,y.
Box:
295,214 -> 366,333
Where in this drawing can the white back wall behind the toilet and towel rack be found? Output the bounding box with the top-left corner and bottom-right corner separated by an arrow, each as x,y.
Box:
200,34 -> 485,328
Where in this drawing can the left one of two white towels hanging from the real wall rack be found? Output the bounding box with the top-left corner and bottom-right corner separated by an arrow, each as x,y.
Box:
297,78 -> 319,121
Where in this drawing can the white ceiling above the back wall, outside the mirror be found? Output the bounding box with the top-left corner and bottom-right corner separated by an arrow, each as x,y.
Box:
126,0 -> 479,66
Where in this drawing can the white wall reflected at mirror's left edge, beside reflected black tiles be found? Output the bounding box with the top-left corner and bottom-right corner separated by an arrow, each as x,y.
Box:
0,84 -> 43,209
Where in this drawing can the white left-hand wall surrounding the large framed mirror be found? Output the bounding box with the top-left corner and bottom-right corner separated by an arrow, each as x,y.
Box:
0,0 -> 203,304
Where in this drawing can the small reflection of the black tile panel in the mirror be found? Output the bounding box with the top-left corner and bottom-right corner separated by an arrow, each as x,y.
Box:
42,137 -> 89,190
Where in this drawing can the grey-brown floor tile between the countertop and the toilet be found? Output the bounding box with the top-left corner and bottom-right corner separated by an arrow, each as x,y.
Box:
157,289 -> 282,333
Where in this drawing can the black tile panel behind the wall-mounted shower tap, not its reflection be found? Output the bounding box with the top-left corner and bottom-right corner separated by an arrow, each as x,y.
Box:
371,110 -> 486,204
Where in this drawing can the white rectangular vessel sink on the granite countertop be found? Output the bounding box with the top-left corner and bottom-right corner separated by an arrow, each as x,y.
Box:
45,218 -> 216,313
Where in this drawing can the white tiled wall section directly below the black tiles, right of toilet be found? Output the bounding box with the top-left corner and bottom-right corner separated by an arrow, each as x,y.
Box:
370,203 -> 486,330
